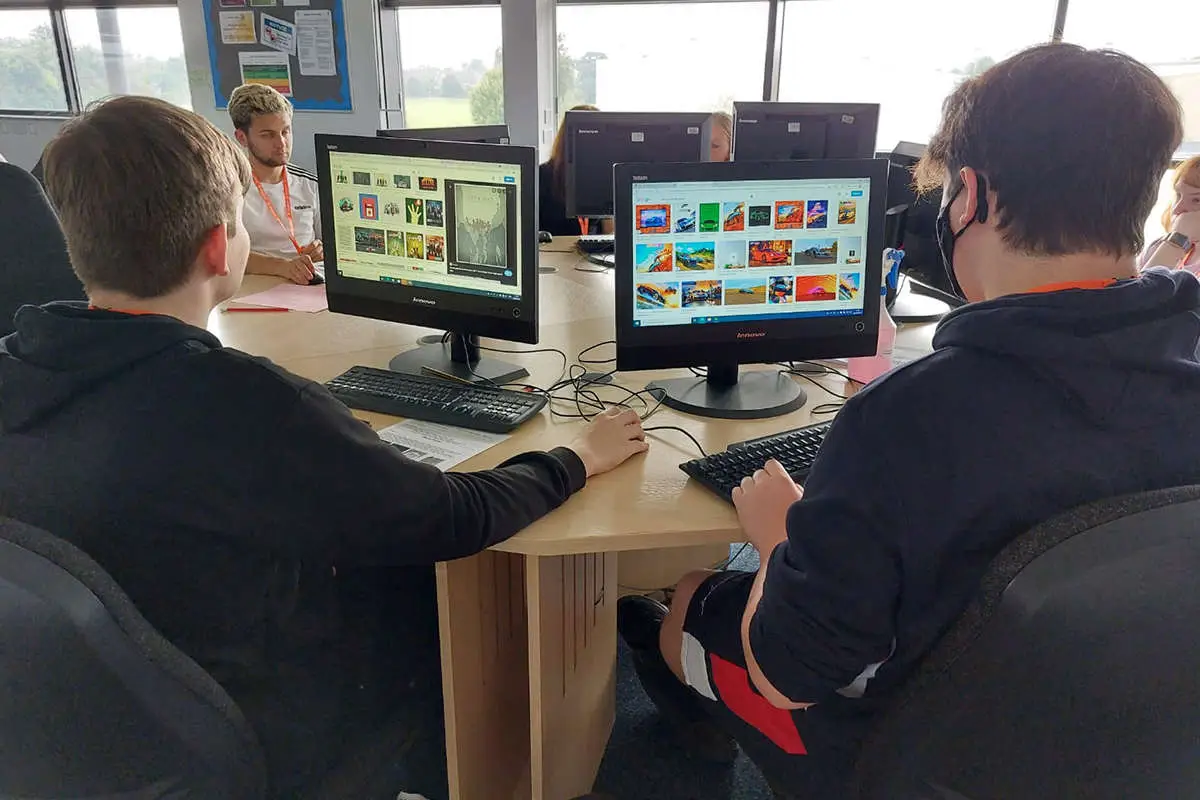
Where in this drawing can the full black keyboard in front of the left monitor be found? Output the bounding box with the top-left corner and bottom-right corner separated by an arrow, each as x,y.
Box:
325,367 -> 546,433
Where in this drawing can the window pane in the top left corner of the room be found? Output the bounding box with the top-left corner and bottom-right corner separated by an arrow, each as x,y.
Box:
0,10 -> 67,112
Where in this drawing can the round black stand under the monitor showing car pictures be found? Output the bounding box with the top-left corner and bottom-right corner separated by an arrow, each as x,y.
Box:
646,363 -> 808,420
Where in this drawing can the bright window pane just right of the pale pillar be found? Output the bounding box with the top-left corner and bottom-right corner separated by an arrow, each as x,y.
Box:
557,1 -> 768,116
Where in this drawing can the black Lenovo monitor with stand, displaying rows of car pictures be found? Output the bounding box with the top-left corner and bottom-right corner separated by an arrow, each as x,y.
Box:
614,160 -> 887,419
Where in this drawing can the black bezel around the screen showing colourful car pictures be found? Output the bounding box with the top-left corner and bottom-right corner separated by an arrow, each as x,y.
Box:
613,158 -> 888,371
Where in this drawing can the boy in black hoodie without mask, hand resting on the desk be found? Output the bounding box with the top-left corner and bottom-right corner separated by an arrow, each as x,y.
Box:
0,97 -> 647,795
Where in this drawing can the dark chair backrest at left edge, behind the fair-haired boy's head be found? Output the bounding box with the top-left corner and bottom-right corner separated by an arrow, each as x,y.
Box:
0,163 -> 85,336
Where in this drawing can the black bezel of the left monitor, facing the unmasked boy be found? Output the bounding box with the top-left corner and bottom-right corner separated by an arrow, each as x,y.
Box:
314,133 -> 539,344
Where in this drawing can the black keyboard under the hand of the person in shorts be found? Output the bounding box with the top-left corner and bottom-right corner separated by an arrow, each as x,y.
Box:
679,422 -> 832,503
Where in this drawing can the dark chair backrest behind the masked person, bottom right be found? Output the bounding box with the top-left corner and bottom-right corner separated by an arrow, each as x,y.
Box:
851,486 -> 1200,800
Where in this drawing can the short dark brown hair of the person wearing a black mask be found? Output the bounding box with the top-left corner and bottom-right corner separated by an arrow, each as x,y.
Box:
917,44 -> 1183,257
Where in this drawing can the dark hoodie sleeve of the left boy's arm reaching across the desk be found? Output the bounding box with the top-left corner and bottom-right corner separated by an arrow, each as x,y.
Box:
248,384 -> 587,565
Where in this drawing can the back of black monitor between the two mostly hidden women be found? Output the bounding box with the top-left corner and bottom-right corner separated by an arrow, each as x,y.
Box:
563,112 -> 712,217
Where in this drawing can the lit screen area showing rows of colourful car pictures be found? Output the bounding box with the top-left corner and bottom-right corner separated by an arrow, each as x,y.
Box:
631,178 -> 878,327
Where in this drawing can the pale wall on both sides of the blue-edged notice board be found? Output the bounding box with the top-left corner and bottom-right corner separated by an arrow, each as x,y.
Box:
179,0 -> 380,169
